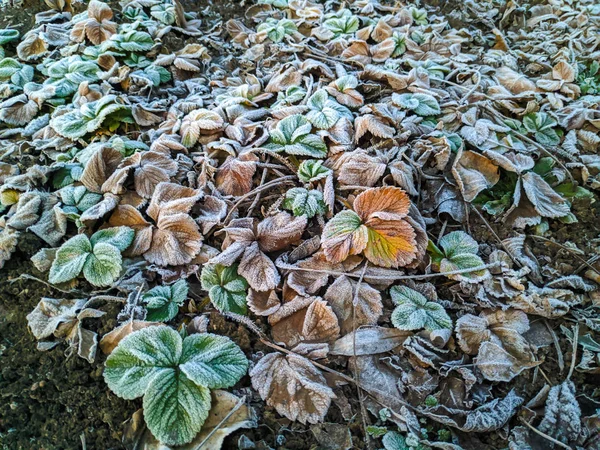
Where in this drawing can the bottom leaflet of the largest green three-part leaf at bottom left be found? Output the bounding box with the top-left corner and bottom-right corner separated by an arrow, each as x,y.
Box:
144,369 -> 211,445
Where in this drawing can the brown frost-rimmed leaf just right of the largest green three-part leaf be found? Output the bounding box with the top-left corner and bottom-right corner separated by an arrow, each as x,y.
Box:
250,353 -> 335,423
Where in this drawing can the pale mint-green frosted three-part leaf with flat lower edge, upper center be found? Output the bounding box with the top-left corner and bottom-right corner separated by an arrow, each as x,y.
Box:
264,114 -> 327,158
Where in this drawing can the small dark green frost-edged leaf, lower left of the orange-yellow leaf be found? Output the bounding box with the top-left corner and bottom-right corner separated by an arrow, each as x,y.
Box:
200,264 -> 248,315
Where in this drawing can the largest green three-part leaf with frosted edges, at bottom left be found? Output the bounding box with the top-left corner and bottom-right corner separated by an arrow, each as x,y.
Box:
104,326 -> 248,445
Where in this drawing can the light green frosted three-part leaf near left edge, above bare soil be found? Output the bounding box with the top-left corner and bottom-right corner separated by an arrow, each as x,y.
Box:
48,227 -> 135,286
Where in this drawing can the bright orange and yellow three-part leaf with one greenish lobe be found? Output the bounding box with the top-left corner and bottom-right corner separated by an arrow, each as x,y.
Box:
321,187 -> 417,267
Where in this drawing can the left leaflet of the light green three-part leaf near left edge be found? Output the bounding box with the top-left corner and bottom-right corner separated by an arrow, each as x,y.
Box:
48,234 -> 91,284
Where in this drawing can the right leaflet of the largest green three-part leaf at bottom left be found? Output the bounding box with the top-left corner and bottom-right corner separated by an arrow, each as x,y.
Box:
180,333 -> 248,389
